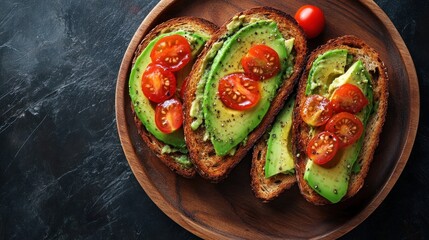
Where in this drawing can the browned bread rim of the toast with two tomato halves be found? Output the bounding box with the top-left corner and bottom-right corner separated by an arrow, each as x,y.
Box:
184,7 -> 307,182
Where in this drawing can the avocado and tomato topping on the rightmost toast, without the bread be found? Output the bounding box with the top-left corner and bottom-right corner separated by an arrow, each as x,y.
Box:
301,49 -> 373,203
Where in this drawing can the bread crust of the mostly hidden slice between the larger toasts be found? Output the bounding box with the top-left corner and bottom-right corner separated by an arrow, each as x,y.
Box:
250,134 -> 296,203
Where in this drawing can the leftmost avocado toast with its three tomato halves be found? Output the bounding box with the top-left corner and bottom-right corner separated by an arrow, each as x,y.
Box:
129,17 -> 217,177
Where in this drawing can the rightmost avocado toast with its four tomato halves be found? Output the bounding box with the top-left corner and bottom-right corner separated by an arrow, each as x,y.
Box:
293,35 -> 388,205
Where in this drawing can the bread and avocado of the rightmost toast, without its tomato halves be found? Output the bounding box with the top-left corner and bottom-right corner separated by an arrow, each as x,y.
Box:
292,36 -> 388,205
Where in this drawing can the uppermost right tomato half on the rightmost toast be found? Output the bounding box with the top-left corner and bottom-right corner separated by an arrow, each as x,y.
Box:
331,83 -> 369,113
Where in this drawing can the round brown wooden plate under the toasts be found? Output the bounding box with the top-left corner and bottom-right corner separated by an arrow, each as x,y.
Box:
116,0 -> 420,239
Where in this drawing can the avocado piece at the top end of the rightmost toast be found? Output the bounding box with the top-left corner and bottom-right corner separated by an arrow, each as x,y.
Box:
305,49 -> 347,97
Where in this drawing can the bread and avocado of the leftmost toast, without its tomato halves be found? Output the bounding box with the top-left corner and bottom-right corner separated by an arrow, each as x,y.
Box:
129,17 -> 217,178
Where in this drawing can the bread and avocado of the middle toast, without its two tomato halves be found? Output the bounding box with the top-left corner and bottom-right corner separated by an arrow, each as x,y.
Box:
184,7 -> 307,182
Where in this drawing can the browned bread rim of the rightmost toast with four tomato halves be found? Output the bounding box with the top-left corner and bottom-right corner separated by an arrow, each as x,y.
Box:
292,35 -> 388,205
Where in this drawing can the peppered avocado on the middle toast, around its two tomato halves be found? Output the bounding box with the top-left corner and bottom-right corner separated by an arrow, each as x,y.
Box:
190,15 -> 294,156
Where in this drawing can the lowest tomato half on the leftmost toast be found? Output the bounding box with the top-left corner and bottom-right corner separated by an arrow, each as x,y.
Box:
155,98 -> 183,133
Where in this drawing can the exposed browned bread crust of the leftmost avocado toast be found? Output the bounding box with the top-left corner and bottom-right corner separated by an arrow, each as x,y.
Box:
131,17 -> 218,178
